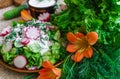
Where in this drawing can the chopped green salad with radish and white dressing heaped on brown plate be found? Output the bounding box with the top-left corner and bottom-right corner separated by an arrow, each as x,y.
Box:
0,19 -> 65,69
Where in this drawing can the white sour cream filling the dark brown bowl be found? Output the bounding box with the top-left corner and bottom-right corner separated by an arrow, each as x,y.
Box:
29,0 -> 56,8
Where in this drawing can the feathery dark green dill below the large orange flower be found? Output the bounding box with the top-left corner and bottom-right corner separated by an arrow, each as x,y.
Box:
61,49 -> 120,79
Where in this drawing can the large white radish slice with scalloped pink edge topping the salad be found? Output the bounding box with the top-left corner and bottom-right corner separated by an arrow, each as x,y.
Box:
25,26 -> 40,40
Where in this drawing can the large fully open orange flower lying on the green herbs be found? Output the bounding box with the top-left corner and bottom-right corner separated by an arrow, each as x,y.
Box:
66,32 -> 98,62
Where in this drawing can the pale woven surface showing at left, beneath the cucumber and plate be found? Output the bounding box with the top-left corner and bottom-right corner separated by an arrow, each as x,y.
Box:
0,6 -> 36,79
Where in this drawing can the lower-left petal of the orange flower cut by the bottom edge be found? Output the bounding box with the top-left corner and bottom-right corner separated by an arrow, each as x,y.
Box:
37,68 -> 56,79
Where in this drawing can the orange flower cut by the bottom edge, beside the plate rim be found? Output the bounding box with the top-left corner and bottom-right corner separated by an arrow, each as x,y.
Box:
37,61 -> 61,79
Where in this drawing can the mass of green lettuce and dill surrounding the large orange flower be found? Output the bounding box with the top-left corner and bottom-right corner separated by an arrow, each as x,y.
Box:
51,0 -> 120,79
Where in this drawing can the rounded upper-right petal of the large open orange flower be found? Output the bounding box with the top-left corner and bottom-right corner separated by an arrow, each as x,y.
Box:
86,32 -> 98,45
